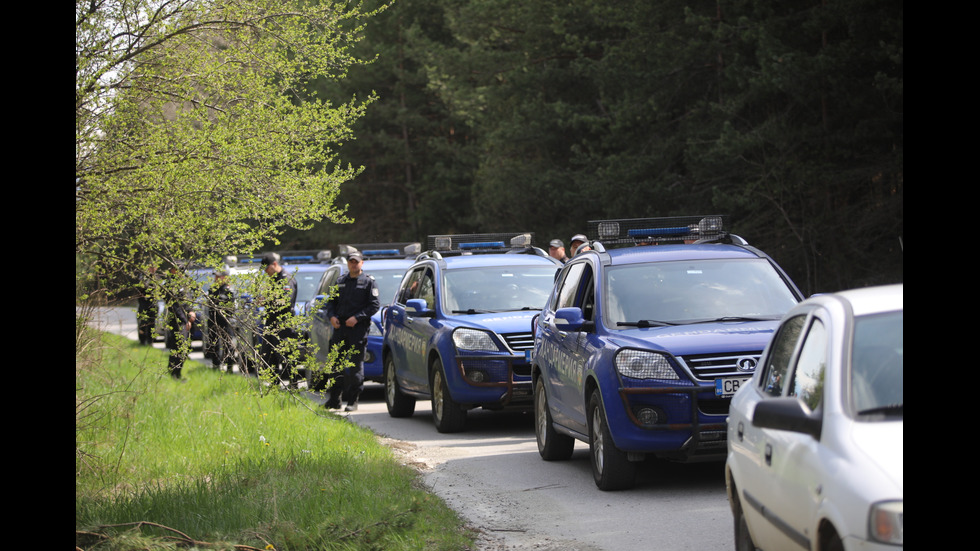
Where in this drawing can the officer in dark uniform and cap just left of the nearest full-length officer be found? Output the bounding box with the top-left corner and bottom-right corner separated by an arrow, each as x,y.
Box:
260,253 -> 299,387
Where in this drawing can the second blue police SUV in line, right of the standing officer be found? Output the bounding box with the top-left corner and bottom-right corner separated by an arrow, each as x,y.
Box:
381,233 -> 560,432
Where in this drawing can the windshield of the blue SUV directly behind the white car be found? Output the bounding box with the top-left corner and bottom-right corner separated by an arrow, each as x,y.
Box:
603,258 -> 797,329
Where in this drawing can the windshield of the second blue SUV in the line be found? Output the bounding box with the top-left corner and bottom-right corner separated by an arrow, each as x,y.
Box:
443,266 -> 556,314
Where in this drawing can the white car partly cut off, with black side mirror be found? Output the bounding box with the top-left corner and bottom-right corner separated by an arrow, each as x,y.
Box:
725,285 -> 905,551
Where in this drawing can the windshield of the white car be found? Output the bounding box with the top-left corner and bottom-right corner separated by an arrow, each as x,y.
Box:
851,311 -> 905,415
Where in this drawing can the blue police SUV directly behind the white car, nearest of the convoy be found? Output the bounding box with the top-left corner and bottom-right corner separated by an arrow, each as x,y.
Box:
531,216 -> 802,490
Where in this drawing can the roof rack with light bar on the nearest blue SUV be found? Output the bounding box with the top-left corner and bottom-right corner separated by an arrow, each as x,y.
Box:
588,214 -> 748,245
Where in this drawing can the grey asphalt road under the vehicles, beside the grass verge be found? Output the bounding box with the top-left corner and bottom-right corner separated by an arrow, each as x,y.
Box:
88,308 -> 734,551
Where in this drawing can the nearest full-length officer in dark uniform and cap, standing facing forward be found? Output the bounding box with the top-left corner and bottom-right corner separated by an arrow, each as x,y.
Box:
326,251 -> 381,411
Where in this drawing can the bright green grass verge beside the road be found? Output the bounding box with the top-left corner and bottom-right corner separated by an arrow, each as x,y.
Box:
75,334 -> 473,550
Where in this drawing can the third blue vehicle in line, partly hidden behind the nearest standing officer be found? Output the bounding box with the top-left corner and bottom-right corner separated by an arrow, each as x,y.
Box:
310,243 -> 422,383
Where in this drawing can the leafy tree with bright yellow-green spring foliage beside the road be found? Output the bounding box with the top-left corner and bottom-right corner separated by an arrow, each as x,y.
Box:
75,0 -> 382,291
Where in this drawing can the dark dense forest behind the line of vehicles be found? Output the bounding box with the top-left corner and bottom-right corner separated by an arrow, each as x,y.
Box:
277,0 -> 904,294
